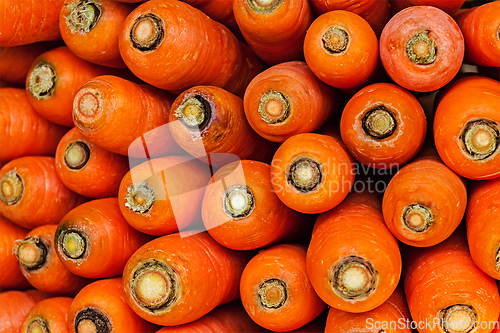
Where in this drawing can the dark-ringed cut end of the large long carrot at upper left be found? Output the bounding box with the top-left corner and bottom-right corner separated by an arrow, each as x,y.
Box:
130,14 -> 165,52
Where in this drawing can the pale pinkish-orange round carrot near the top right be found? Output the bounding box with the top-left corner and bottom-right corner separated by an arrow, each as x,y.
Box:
380,6 -> 464,92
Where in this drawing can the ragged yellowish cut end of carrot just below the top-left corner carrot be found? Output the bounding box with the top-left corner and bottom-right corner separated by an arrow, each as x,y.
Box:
28,62 -> 57,100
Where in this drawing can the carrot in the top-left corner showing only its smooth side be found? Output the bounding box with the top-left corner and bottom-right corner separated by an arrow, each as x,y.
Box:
0,0 -> 64,47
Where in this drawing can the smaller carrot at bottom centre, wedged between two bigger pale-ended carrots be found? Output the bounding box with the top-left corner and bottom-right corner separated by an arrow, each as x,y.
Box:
240,244 -> 326,332
